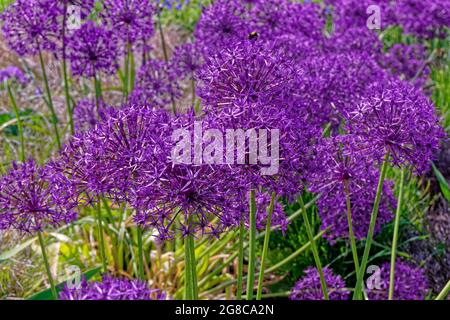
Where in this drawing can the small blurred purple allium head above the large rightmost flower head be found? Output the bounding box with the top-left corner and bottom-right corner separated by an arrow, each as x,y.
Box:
381,44 -> 431,88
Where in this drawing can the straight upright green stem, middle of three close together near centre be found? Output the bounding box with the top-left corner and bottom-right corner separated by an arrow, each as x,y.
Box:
247,190 -> 256,300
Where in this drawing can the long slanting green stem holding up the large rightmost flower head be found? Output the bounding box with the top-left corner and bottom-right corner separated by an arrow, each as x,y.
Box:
353,152 -> 389,300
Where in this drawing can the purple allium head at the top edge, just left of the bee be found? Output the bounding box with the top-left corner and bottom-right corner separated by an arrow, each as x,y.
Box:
194,0 -> 253,53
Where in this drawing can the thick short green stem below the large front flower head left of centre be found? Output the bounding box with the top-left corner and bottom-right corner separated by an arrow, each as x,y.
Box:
184,217 -> 198,300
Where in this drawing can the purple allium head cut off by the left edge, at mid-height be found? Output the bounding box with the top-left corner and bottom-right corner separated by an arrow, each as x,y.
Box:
0,160 -> 78,234
